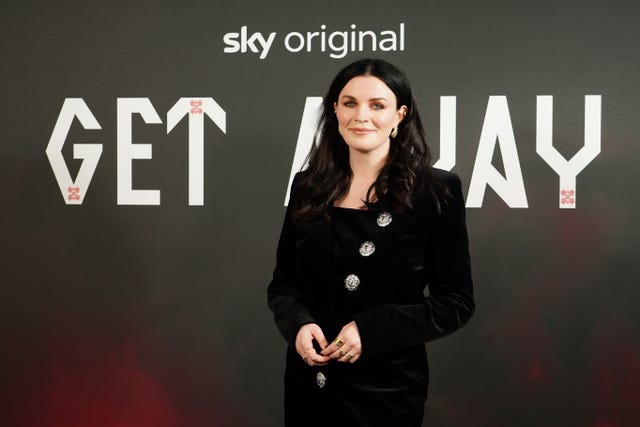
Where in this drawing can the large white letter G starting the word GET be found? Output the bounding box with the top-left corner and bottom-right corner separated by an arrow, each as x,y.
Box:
46,98 -> 102,205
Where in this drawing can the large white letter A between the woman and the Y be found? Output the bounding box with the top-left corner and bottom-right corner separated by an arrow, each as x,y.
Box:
467,96 -> 528,208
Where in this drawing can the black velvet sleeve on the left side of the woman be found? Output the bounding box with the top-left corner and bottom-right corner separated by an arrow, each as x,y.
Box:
267,179 -> 316,348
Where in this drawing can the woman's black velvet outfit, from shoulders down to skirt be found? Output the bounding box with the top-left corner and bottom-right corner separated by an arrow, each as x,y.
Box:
267,169 -> 475,427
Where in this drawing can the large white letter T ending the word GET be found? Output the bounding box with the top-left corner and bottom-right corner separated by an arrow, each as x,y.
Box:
167,98 -> 227,206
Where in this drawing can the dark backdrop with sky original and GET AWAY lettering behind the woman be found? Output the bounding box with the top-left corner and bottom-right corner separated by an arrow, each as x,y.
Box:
0,0 -> 640,427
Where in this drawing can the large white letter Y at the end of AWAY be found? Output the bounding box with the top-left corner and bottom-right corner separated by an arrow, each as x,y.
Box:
536,95 -> 601,209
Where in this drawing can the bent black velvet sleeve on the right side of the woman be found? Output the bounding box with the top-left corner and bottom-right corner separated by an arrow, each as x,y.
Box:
354,173 -> 475,356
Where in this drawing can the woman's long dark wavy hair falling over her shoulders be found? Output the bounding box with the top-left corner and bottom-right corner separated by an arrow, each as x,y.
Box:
292,59 -> 431,219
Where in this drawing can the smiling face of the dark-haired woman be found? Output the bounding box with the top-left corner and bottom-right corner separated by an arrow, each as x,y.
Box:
334,76 -> 407,155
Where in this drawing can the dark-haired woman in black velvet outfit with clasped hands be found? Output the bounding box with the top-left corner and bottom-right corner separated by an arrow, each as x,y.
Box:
268,59 -> 474,427
